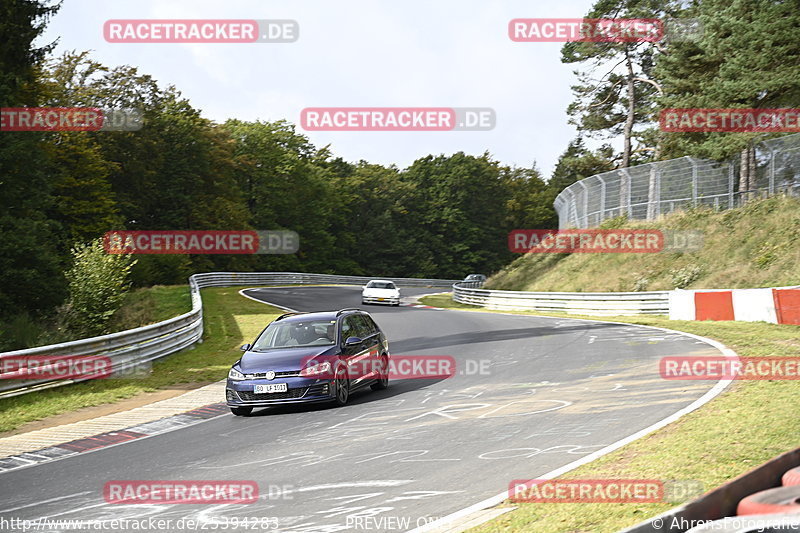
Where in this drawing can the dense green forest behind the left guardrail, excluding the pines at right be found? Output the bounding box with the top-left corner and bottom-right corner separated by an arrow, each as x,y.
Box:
0,1 -> 576,338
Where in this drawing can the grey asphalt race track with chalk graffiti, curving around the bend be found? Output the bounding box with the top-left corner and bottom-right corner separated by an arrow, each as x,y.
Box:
0,287 -> 718,533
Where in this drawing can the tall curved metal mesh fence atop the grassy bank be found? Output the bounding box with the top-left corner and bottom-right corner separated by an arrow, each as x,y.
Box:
554,134 -> 800,229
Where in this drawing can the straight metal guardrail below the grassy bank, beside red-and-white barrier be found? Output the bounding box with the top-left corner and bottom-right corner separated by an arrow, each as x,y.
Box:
453,282 -> 669,316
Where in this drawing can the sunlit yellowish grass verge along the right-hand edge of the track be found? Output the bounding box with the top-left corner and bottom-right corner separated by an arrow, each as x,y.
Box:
420,295 -> 800,533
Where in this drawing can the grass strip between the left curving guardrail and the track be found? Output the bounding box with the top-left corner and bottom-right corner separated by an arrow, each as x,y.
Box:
0,287 -> 284,432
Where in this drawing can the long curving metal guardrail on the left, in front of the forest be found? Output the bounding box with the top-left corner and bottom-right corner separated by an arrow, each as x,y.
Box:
0,272 -> 456,398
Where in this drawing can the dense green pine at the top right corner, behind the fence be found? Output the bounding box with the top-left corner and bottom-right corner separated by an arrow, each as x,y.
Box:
656,0 -> 800,194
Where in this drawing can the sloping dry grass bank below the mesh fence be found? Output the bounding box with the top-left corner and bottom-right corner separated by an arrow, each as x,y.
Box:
486,196 -> 800,292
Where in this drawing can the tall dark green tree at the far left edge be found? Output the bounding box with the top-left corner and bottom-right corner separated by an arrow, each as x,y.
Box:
0,0 -> 66,319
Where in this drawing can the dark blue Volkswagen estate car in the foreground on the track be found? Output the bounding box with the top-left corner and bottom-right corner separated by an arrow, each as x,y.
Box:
225,309 -> 390,416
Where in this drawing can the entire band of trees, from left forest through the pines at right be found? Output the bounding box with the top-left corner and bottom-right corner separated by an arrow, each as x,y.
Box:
0,0 -> 800,350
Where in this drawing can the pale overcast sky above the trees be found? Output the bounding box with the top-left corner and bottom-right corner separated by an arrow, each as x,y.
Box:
37,0 -> 592,177
